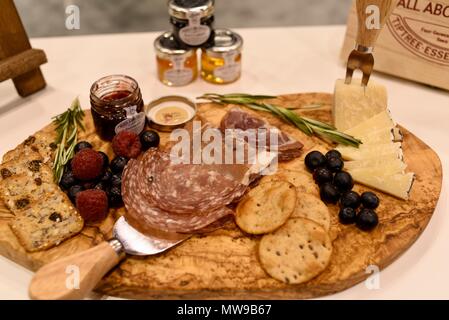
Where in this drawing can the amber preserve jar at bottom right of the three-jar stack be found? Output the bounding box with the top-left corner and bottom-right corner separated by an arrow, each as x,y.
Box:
201,29 -> 243,84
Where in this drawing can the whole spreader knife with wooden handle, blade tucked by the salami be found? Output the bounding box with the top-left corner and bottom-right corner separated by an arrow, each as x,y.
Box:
29,217 -> 191,300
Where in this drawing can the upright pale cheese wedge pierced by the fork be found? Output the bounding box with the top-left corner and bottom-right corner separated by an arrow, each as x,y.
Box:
332,80 -> 387,131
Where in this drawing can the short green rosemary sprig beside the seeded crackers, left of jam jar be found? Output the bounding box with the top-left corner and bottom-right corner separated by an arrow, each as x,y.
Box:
52,98 -> 84,183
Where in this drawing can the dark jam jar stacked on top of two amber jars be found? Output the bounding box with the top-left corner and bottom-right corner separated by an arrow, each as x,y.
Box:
168,0 -> 215,48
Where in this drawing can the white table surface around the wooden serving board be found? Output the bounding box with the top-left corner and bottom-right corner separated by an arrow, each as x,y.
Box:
0,26 -> 449,299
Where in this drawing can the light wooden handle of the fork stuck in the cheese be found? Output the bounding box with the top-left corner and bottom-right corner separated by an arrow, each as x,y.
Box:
356,0 -> 397,48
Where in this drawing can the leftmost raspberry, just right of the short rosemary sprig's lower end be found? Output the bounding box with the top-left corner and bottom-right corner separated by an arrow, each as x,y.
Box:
71,149 -> 104,181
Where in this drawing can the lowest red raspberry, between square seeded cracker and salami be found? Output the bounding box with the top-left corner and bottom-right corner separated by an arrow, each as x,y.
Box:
76,189 -> 109,222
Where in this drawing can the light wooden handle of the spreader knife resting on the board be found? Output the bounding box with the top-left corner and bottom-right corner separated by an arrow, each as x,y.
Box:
29,242 -> 120,300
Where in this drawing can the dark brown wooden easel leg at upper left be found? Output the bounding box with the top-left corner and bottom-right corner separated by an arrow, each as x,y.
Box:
0,0 -> 47,97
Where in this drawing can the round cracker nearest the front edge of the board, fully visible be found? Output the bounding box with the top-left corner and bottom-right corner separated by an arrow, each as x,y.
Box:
259,218 -> 332,284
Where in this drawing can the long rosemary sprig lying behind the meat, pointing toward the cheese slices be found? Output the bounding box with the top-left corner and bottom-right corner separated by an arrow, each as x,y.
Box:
198,93 -> 362,148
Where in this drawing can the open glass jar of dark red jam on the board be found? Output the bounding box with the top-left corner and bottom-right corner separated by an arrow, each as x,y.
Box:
90,75 -> 145,141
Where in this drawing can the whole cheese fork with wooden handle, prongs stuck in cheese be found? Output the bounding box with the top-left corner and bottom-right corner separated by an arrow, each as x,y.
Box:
345,0 -> 397,86
